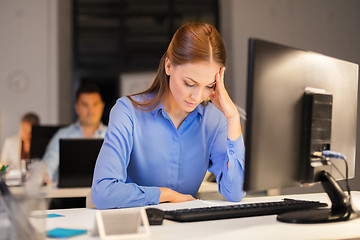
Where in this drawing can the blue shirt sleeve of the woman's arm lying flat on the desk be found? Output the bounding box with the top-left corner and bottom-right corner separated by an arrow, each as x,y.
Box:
91,98 -> 160,209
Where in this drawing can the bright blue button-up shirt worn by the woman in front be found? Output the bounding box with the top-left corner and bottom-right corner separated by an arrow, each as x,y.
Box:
91,97 -> 245,209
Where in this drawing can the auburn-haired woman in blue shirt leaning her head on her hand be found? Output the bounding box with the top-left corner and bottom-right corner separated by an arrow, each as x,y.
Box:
91,23 -> 245,209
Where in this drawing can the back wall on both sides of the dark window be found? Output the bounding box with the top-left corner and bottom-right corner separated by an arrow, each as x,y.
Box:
0,0 -> 360,190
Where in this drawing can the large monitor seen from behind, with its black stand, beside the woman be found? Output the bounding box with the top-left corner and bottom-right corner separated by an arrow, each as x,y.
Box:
244,39 -> 358,222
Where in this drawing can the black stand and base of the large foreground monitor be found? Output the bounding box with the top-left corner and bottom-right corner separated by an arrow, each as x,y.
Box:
277,171 -> 360,223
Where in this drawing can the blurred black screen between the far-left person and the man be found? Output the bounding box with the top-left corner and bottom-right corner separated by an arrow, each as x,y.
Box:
30,125 -> 63,159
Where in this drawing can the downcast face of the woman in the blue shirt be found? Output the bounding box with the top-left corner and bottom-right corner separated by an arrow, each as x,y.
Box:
165,59 -> 221,113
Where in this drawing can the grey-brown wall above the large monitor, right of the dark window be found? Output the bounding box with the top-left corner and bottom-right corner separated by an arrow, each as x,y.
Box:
221,0 -> 360,193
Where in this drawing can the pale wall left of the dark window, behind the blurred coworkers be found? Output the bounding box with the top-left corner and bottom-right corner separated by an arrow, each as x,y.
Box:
0,0 -> 71,146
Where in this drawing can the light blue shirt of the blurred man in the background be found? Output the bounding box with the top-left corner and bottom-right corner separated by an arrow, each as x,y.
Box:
43,121 -> 107,182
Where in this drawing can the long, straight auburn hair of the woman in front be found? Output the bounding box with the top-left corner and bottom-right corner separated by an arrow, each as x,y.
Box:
127,22 -> 226,111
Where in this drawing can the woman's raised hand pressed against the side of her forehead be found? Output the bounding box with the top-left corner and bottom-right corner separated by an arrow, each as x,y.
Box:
210,67 -> 240,119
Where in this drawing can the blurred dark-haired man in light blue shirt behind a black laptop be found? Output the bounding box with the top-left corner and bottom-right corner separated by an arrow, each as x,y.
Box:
43,84 -> 107,185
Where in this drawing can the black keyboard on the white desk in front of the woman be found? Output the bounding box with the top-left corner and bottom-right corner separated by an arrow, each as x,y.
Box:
164,198 -> 327,222
